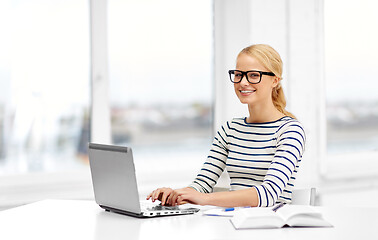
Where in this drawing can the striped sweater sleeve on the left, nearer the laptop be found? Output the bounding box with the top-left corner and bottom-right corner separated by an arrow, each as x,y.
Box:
189,124 -> 228,193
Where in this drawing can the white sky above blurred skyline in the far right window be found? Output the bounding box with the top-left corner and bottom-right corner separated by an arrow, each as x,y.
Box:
324,0 -> 378,102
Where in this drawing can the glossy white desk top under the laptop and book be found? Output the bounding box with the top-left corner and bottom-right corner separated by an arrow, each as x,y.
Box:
0,200 -> 378,240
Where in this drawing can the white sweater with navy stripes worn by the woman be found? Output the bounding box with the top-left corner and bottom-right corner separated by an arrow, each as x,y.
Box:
190,117 -> 306,207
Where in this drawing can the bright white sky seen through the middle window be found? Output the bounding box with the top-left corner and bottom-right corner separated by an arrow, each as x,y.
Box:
108,0 -> 213,104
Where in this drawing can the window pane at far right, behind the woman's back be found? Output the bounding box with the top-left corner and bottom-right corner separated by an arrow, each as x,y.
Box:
324,0 -> 378,153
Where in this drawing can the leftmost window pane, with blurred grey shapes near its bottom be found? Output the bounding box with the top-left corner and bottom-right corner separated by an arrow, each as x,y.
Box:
0,0 -> 89,174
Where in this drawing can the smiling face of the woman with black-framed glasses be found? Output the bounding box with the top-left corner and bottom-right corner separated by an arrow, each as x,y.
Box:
234,53 -> 279,106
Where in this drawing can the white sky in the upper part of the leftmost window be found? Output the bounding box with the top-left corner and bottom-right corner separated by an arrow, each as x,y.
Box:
0,0 -> 90,108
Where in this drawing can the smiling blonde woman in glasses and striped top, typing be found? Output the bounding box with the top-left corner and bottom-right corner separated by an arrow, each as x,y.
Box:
147,44 -> 305,207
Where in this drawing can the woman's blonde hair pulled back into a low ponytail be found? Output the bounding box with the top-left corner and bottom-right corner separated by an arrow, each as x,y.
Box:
238,44 -> 295,118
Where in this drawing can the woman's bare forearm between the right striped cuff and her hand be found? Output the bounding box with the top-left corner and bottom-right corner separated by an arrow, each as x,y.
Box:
205,188 -> 258,207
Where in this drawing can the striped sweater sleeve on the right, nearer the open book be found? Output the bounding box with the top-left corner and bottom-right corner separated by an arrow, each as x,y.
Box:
254,121 -> 305,207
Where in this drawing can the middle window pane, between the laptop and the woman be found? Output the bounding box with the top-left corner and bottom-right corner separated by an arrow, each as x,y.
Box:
108,0 -> 213,185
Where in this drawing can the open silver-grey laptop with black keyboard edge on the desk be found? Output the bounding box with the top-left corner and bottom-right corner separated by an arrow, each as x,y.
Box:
88,143 -> 199,217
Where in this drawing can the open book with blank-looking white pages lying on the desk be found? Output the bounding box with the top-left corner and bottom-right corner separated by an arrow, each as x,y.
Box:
231,204 -> 332,229
